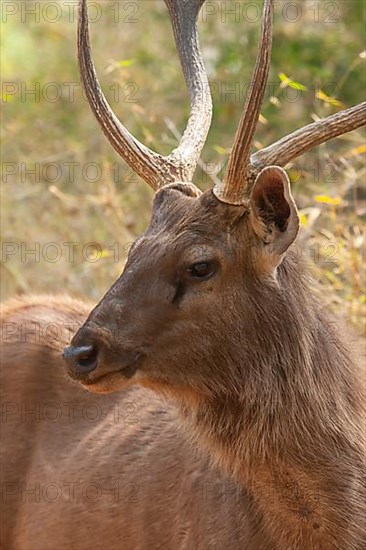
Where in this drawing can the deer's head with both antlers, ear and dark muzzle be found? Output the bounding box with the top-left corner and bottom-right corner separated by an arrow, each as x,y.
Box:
64,0 -> 366,399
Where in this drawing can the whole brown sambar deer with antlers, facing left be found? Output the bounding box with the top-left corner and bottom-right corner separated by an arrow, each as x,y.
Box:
2,0 -> 365,550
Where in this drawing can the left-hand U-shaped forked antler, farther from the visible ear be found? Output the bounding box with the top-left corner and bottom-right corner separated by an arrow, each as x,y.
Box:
78,0 -> 212,190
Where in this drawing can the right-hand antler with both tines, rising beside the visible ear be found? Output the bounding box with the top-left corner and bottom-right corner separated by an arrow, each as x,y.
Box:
214,0 -> 366,205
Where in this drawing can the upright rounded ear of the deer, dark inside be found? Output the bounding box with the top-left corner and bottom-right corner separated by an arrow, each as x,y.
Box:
250,166 -> 299,256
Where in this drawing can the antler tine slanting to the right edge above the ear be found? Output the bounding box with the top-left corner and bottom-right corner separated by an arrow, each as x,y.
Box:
251,102 -> 366,170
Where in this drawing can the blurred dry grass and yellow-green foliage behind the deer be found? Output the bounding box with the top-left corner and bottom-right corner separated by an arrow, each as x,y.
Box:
1,0 -> 366,330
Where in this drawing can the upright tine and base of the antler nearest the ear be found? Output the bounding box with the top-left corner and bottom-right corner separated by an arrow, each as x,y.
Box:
214,0 -> 273,204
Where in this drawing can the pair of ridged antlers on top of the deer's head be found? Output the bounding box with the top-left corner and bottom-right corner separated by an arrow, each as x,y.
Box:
78,0 -> 366,205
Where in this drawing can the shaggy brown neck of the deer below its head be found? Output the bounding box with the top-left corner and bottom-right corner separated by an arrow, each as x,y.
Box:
180,268 -> 363,550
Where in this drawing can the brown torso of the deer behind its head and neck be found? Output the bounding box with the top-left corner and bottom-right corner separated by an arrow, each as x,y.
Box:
1,296 -> 260,550
